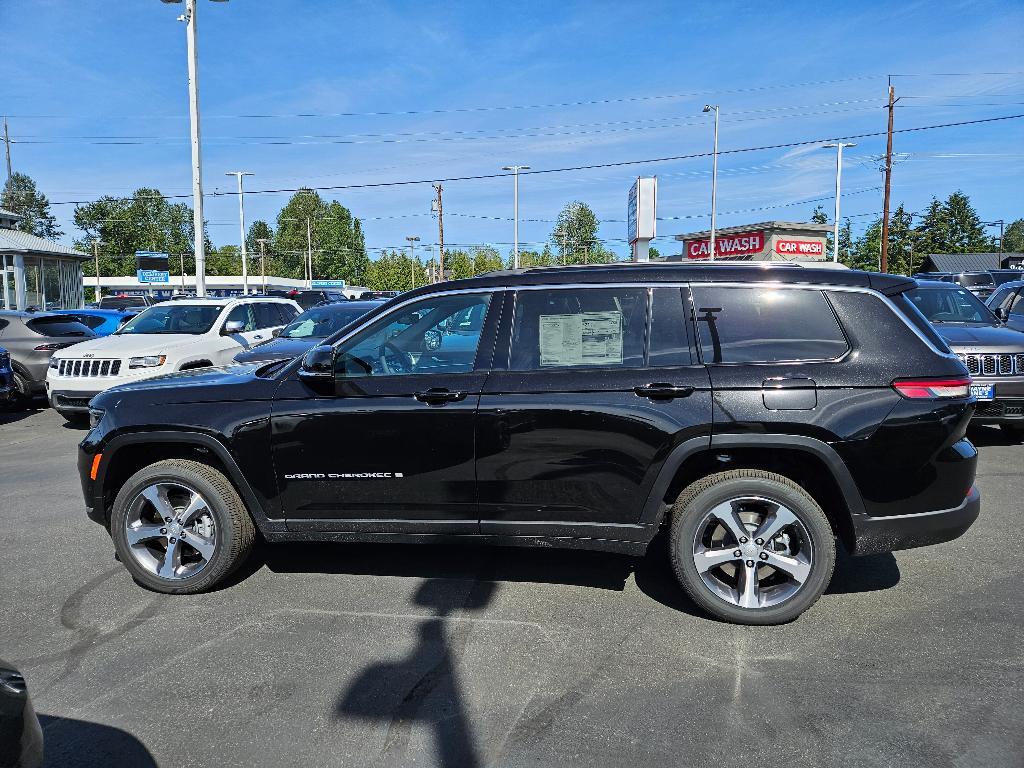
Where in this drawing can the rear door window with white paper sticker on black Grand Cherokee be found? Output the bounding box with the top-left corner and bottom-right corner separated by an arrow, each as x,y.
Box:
509,288 -> 647,371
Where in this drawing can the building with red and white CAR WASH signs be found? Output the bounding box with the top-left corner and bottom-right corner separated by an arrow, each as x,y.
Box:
667,221 -> 833,261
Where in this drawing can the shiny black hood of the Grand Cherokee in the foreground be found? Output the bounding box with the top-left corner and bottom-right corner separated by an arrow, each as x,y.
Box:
93,366 -> 279,409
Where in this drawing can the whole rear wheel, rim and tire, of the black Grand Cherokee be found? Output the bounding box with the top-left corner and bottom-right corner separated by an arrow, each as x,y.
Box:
670,469 -> 836,625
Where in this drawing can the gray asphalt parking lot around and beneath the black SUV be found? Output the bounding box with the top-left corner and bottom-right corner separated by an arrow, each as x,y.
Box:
0,410 -> 1024,768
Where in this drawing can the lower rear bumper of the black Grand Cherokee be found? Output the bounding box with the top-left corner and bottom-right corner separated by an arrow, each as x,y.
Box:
853,487 -> 981,555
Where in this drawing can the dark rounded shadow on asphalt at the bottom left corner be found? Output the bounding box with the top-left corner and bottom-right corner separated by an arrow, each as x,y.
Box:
39,715 -> 157,768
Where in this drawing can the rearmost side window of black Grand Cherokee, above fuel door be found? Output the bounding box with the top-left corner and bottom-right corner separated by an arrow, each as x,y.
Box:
692,286 -> 850,364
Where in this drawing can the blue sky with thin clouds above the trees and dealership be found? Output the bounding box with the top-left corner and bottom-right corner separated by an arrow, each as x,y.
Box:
0,0 -> 1024,259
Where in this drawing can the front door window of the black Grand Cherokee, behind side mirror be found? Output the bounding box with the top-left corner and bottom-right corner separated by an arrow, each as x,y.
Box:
335,293 -> 490,379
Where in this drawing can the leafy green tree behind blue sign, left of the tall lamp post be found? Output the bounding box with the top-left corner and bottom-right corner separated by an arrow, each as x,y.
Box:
75,187 -> 207,275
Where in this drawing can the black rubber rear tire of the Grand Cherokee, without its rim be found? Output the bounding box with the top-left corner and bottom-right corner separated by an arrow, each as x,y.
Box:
669,469 -> 836,625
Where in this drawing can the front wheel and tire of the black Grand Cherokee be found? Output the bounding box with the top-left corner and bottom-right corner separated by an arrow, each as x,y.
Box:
111,459 -> 256,594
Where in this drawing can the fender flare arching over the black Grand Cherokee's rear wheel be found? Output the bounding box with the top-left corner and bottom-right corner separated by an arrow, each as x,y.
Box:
640,434 -> 867,525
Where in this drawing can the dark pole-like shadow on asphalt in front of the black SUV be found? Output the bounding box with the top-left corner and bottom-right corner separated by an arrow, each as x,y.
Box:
334,577 -> 496,768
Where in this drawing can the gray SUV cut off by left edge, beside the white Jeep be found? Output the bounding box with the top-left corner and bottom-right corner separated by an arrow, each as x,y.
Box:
0,311 -> 96,407
